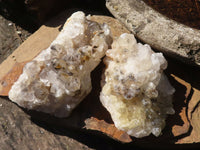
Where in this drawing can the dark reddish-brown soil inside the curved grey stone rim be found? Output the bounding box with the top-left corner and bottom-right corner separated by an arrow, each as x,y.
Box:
144,0 -> 200,29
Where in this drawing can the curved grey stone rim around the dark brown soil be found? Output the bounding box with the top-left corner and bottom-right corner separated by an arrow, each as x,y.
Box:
106,0 -> 200,66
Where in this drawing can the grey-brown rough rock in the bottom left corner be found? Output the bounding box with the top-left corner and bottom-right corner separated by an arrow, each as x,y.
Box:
0,98 -> 92,150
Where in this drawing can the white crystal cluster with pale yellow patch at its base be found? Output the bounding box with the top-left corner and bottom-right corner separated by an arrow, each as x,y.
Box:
100,33 -> 175,138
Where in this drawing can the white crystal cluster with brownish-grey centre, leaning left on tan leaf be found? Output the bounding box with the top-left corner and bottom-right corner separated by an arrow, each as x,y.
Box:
9,12 -> 112,117
